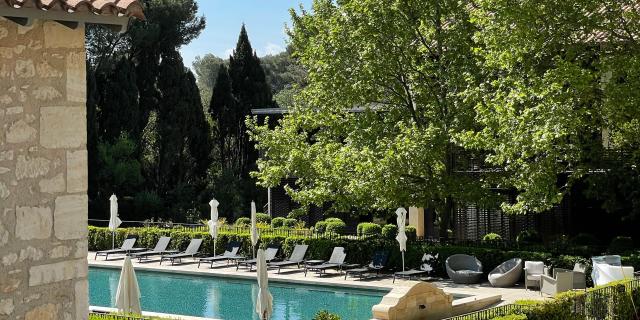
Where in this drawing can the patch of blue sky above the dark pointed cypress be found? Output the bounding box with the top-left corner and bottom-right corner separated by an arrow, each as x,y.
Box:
180,0 -> 312,67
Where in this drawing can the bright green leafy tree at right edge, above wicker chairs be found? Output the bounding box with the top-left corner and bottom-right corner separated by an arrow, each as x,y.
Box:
460,0 -> 640,213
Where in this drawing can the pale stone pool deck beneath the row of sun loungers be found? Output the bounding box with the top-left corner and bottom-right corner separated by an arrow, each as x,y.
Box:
87,252 -> 547,304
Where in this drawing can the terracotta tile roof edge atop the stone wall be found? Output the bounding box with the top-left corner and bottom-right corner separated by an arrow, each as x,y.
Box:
0,0 -> 144,20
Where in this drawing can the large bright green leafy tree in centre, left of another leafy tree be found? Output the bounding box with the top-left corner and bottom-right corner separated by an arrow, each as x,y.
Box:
251,0 -> 490,236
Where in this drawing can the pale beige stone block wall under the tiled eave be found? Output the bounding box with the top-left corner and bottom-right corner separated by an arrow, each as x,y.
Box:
0,18 -> 88,320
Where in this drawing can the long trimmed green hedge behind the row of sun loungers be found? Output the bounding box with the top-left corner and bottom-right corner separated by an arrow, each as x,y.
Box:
88,227 -> 640,277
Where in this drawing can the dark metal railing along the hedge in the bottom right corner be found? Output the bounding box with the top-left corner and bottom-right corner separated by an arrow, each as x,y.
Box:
445,279 -> 640,320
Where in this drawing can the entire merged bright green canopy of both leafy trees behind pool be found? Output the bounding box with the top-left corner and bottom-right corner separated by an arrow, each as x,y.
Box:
251,0 -> 640,231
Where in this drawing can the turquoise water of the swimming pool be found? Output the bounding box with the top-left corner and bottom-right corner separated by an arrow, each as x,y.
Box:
89,267 -> 386,320
